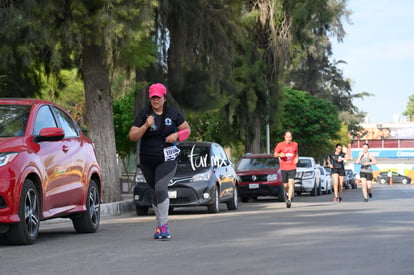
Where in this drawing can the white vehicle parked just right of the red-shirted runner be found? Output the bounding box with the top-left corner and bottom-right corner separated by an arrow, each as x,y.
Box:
295,157 -> 322,196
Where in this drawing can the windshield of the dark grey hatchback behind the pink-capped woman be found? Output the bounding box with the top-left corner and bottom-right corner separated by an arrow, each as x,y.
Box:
177,145 -> 211,172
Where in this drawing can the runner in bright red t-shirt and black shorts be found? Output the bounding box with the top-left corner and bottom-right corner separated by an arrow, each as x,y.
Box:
274,131 -> 299,208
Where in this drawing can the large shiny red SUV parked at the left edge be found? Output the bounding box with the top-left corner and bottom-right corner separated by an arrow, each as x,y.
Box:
0,99 -> 101,244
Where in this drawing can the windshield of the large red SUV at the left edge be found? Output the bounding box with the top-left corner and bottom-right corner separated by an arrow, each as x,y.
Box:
0,105 -> 31,137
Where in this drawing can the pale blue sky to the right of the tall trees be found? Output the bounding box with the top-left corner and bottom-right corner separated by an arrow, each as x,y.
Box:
332,0 -> 414,123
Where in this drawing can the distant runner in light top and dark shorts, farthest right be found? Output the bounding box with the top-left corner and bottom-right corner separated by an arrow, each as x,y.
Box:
355,143 -> 377,202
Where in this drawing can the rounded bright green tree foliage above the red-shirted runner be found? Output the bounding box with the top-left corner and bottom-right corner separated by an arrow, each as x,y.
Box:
275,88 -> 341,160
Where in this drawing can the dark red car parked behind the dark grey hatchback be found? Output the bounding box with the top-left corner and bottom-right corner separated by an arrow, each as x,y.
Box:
236,154 -> 285,202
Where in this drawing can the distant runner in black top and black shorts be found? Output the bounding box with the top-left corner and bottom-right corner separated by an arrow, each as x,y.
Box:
327,143 -> 346,202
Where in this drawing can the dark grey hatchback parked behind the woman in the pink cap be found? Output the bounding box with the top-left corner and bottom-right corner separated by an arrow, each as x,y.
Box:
133,141 -> 239,215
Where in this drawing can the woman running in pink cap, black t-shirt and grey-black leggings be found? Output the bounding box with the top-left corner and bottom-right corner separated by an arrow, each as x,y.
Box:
129,83 -> 190,239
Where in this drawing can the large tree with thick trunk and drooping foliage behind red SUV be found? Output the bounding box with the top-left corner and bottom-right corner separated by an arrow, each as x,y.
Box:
0,0 -> 155,202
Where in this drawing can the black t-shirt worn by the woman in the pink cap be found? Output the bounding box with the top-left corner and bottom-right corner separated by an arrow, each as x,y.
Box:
134,107 -> 185,157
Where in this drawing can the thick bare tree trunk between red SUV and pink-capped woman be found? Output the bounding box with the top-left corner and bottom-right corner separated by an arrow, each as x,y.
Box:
82,45 -> 122,202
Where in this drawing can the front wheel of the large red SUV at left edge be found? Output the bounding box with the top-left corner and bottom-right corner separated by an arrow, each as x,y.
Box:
6,179 -> 40,244
